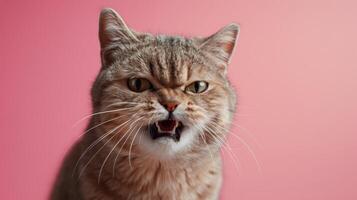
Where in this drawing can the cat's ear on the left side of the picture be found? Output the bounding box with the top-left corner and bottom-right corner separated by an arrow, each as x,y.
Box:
99,8 -> 139,66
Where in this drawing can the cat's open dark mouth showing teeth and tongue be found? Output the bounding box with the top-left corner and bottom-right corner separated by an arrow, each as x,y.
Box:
150,119 -> 183,142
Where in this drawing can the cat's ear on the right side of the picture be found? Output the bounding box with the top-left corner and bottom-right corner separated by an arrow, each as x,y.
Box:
199,24 -> 239,72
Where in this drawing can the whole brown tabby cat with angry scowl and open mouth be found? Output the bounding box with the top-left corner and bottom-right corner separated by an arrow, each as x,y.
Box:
50,8 -> 239,200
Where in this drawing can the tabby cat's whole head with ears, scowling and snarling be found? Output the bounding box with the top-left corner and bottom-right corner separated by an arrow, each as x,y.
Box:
92,9 -> 238,158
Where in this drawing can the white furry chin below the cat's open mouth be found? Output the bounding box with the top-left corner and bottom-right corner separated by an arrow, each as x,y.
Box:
139,129 -> 196,160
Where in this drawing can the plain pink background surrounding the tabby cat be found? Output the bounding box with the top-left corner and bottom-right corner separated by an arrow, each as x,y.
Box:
0,0 -> 357,200
